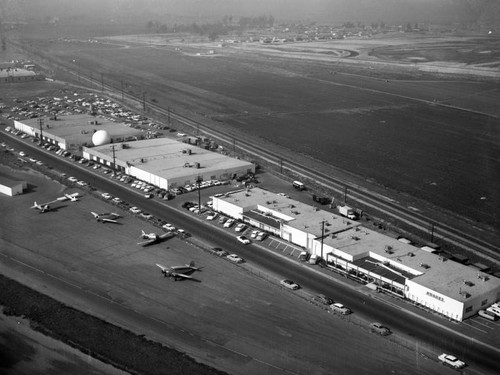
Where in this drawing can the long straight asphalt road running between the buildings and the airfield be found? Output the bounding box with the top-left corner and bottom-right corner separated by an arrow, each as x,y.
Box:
0,131 -> 500,373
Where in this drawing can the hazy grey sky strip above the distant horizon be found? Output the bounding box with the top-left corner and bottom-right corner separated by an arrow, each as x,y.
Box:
0,0 -> 500,23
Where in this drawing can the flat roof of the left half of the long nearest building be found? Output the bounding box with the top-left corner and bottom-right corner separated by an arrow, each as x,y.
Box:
223,188 -> 360,237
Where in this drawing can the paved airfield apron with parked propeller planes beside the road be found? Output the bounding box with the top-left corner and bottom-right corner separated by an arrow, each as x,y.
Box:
0,164 -> 450,374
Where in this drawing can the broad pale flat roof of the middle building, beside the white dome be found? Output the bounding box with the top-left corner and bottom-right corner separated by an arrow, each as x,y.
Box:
88,138 -> 253,178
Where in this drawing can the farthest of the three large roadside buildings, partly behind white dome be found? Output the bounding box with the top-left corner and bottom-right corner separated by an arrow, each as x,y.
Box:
14,114 -> 143,150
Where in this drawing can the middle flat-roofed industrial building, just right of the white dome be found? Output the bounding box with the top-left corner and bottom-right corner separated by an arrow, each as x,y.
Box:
83,138 -> 255,189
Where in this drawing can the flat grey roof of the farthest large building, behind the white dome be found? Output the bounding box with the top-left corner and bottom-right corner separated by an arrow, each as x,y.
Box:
20,114 -> 143,145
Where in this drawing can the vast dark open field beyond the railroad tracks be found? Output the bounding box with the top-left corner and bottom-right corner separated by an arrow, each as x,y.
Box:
6,26 -> 500,232
